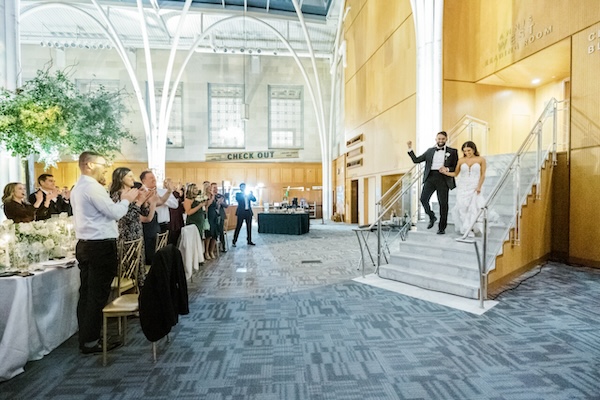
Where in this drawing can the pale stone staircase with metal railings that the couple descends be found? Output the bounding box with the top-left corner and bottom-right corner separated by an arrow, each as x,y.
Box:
366,99 -> 559,300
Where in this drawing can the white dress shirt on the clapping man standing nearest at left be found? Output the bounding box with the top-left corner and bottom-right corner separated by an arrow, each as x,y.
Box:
71,175 -> 129,240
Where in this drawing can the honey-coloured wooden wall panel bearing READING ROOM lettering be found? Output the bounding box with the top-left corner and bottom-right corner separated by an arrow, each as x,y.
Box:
444,0 -> 600,82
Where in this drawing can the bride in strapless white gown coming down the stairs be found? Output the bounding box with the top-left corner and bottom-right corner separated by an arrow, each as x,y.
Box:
440,141 -> 486,238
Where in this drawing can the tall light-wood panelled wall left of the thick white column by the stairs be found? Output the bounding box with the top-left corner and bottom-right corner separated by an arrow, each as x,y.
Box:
344,0 -> 416,221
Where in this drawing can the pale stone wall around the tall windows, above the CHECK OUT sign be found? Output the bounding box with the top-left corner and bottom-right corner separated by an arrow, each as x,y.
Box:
22,45 -> 331,162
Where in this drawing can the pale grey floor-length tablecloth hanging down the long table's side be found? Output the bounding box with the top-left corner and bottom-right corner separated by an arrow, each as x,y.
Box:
0,266 -> 80,382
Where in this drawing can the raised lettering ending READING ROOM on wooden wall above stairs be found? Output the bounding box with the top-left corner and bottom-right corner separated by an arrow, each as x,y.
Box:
483,16 -> 554,67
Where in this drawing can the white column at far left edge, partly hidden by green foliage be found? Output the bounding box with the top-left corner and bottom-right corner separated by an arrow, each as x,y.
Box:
0,0 -> 23,212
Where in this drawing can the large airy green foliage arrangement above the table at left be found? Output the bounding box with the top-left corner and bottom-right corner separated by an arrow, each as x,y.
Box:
0,69 -> 135,167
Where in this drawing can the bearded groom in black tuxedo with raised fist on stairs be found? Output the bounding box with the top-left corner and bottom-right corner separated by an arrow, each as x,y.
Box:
407,131 -> 458,235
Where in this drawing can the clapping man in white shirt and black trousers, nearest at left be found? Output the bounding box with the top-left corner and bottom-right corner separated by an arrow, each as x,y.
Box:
71,152 -> 138,354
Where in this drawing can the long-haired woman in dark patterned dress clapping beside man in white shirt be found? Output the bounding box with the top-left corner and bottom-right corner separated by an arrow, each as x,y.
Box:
110,167 -> 157,286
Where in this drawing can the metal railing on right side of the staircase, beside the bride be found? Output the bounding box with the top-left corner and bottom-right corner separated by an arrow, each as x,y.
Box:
464,98 -> 564,308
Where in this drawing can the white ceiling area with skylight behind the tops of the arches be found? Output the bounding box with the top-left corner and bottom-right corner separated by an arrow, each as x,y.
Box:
20,0 -> 342,57
